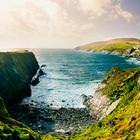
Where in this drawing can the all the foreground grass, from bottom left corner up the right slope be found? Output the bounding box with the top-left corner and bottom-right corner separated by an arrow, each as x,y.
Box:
0,49 -> 140,140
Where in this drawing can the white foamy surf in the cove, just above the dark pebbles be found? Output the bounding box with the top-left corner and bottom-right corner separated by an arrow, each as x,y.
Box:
23,77 -> 100,108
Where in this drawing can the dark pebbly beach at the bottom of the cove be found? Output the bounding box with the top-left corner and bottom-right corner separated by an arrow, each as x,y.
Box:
9,104 -> 96,135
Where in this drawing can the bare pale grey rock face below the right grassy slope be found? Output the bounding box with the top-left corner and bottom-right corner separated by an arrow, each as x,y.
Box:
86,84 -> 120,120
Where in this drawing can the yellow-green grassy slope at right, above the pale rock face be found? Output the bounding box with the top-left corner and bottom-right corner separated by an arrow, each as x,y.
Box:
70,68 -> 140,140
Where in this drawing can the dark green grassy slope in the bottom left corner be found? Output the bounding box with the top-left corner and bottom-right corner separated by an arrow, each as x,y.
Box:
0,97 -> 41,140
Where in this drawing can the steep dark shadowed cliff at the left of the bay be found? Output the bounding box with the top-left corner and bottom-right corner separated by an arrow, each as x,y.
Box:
0,51 -> 39,104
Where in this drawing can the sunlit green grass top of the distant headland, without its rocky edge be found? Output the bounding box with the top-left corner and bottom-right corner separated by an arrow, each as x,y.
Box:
77,38 -> 140,54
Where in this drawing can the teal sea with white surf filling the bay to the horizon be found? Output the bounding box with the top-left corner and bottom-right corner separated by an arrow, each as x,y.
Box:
22,49 -> 140,108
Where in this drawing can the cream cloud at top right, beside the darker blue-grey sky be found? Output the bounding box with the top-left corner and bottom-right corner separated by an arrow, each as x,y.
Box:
79,0 -> 134,22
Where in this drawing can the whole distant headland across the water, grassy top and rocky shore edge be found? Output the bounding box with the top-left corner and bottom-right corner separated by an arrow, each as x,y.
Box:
76,38 -> 140,58
